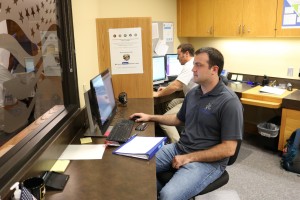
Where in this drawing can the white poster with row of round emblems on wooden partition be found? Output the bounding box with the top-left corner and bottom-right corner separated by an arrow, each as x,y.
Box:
109,28 -> 143,74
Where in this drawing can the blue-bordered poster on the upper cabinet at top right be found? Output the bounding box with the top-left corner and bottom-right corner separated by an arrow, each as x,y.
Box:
282,0 -> 300,28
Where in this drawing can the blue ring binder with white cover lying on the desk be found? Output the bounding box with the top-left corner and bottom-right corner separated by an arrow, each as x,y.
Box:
113,136 -> 167,160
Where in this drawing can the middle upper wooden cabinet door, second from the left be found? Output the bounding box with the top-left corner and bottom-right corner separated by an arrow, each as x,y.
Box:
214,0 -> 243,37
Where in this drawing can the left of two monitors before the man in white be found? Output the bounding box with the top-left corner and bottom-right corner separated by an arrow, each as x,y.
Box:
152,56 -> 166,85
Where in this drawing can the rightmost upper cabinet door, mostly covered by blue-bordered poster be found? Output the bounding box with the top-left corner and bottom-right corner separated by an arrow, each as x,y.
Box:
276,0 -> 300,37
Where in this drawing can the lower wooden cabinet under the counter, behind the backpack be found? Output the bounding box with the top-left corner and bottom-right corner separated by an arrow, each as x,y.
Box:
278,108 -> 300,151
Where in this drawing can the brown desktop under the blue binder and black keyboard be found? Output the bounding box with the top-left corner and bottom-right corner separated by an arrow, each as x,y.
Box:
46,99 -> 156,200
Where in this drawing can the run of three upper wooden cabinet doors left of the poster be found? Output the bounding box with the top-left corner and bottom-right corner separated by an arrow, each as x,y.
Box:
177,0 -> 277,37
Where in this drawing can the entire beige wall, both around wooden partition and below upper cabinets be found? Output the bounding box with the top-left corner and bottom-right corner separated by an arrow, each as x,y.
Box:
72,0 -> 300,106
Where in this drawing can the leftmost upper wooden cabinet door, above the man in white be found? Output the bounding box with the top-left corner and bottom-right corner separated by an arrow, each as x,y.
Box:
177,0 -> 214,37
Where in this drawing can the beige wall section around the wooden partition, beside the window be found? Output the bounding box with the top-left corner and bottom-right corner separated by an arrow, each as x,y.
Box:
72,0 -> 179,106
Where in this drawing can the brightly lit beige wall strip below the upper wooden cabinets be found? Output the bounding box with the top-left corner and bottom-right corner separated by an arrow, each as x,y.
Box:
189,38 -> 300,79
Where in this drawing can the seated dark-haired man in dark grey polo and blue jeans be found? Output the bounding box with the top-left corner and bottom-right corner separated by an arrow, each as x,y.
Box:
130,47 -> 243,200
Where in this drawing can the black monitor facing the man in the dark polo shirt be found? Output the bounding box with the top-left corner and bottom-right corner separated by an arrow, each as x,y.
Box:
90,70 -> 117,132
